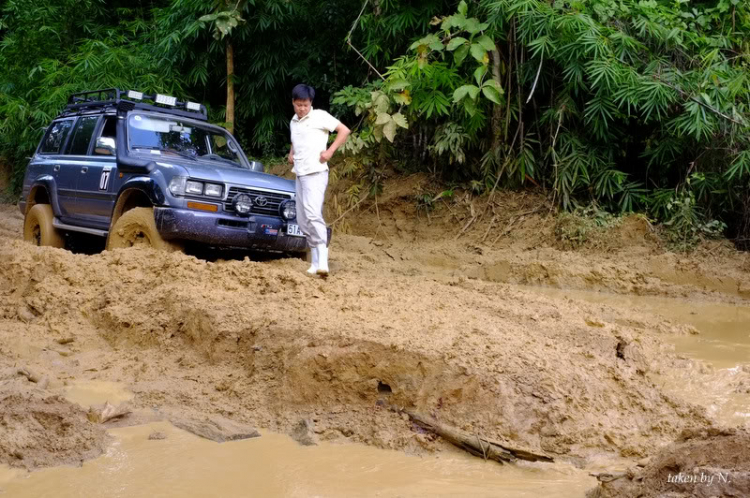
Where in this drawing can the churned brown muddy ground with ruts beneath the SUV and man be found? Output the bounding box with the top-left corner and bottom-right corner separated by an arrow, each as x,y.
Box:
0,194 -> 750,490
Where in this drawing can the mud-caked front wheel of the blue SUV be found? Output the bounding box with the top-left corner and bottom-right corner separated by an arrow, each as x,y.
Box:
107,208 -> 182,252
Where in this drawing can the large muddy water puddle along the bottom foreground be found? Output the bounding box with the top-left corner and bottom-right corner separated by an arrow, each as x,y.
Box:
0,422 -> 596,498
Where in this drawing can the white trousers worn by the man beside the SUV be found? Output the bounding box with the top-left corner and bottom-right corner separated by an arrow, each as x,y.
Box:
296,171 -> 328,247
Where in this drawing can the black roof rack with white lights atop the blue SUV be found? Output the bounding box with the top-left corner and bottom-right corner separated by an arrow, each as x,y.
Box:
63,88 -> 208,121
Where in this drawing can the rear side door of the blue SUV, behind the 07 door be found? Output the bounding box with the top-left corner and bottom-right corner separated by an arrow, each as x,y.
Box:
32,118 -> 78,218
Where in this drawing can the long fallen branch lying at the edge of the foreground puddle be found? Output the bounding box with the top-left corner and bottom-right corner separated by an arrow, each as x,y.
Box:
404,411 -> 554,464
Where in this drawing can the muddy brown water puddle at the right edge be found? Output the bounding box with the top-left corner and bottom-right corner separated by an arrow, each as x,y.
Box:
536,287 -> 750,426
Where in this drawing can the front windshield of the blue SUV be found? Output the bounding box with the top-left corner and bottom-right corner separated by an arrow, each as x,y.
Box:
128,114 -> 249,168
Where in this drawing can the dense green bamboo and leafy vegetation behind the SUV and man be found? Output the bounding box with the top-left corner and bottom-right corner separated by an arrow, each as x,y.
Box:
0,0 -> 750,247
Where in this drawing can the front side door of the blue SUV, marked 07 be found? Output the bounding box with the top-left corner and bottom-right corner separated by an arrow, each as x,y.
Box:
66,116 -> 115,228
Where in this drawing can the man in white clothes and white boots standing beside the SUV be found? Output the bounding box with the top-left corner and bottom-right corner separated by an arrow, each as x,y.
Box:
289,85 -> 350,275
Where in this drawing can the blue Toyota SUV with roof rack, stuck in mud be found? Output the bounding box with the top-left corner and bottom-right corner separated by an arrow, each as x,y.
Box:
19,89 -> 307,253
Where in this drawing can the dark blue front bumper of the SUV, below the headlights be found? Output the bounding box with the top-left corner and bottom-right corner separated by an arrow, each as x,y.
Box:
154,207 -> 307,252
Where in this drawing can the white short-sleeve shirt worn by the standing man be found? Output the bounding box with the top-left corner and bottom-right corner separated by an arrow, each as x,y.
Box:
289,109 -> 341,176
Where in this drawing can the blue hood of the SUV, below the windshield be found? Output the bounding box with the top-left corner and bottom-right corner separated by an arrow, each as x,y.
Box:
157,158 -> 294,192
